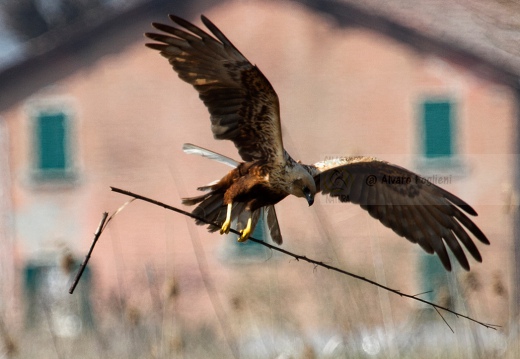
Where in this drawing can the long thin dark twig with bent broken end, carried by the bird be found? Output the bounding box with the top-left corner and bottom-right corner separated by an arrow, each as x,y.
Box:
73,187 -> 500,332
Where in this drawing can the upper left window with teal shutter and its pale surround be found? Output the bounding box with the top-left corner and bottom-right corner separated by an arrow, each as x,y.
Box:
27,99 -> 75,183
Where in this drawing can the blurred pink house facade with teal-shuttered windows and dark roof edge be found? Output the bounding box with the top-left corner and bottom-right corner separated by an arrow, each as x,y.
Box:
0,1 -> 520,358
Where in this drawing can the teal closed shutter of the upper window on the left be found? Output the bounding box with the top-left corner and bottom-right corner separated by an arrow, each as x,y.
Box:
36,112 -> 67,171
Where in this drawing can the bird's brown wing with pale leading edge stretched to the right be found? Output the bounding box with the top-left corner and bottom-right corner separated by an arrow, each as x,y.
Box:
305,157 -> 489,270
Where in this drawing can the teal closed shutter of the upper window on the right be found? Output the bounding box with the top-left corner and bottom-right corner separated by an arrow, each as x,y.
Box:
423,100 -> 453,158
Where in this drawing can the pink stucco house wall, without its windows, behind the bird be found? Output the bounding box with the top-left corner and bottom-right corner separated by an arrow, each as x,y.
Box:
2,2 -> 517,338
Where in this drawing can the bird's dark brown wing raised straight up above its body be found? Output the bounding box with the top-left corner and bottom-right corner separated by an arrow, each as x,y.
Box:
145,15 -> 284,162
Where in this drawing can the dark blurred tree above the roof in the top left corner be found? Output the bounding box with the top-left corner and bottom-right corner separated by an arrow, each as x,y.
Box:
0,0 -> 104,40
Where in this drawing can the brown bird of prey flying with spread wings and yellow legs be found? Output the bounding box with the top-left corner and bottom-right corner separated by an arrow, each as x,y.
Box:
145,15 -> 489,270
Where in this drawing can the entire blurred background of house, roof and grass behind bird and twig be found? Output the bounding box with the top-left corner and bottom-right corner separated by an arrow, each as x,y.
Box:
0,0 -> 520,358
